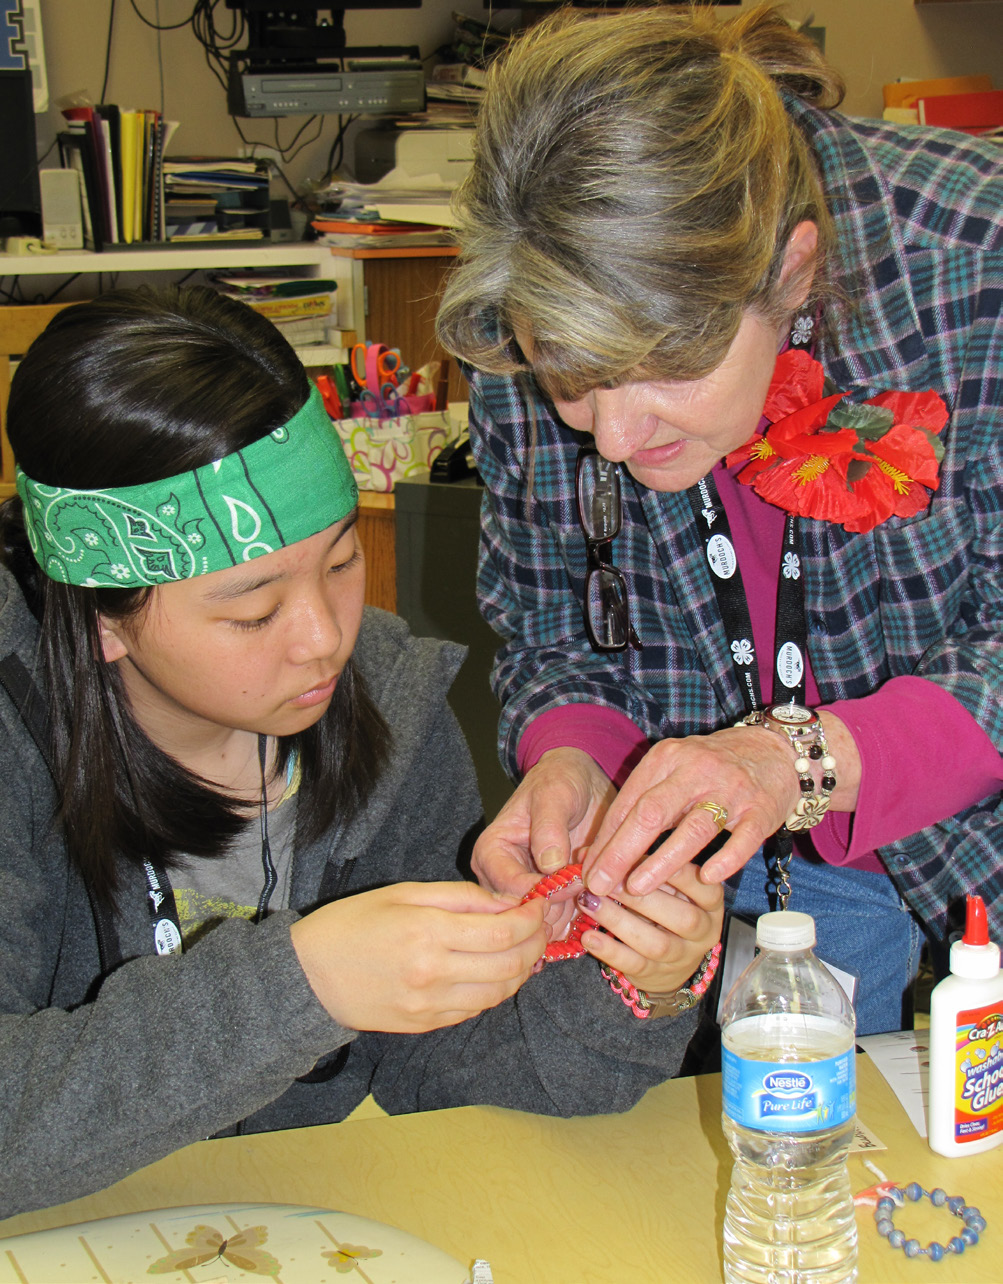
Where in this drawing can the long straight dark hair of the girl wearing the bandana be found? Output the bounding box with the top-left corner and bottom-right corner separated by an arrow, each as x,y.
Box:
0,286 -> 389,903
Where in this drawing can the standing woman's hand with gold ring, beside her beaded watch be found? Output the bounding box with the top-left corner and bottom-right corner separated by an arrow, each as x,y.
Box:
584,713 -> 859,895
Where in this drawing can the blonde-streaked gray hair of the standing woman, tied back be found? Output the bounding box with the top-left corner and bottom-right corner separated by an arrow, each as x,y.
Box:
438,4 -> 844,399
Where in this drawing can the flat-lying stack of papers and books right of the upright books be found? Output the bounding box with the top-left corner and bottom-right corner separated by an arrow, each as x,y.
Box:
163,157 -> 271,241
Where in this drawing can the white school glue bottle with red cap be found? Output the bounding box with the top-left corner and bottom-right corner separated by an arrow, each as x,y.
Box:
927,896 -> 1003,1156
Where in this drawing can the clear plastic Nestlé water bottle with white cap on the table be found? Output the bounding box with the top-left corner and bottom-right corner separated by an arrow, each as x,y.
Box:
722,910 -> 857,1284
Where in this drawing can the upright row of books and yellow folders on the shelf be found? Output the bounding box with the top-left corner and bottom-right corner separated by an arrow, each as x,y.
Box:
58,104 -> 177,249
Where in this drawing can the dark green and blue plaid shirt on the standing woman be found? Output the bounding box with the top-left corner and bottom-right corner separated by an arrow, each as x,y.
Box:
467,103 -> 1003,940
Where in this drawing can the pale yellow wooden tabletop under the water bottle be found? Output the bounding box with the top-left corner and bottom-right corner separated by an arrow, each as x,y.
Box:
0,1055 -> 1003,1284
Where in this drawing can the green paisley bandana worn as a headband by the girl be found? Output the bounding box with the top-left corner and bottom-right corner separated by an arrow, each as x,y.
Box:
17,377 -> 358,588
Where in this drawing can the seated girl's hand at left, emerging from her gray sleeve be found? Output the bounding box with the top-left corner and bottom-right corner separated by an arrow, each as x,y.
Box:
285,882 -> 547,1034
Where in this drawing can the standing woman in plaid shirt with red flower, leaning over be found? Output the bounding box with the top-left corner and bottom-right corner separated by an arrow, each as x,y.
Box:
439,5 -> 1003,1032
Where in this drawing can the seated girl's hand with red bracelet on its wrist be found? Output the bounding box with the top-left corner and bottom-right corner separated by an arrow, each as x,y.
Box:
579,864 -> 724,994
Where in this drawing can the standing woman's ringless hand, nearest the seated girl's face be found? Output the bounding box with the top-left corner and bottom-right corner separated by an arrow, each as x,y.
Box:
473,749 -> 616,932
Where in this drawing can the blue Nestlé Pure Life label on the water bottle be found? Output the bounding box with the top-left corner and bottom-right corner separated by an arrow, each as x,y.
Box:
722,1016 -> 857,1132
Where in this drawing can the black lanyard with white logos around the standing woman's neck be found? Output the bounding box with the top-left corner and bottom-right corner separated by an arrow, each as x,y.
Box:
688,473 -> 808,713
